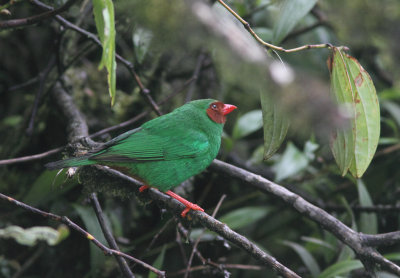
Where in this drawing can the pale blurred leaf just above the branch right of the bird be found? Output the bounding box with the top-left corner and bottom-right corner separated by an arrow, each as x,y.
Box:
273,142 -> 309,182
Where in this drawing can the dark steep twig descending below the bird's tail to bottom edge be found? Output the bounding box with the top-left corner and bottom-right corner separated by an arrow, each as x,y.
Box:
90,193 -> 135,278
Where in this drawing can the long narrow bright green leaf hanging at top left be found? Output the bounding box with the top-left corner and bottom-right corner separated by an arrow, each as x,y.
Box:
93,0 -> 117,105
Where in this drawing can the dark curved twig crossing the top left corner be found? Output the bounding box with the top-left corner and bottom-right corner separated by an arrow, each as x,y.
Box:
0,0 -> 76,30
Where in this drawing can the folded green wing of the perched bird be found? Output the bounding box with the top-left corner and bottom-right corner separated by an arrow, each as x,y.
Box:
89,128 -> 209,163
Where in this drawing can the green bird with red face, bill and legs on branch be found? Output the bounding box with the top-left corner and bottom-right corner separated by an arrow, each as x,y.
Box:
45,99 -> 237,217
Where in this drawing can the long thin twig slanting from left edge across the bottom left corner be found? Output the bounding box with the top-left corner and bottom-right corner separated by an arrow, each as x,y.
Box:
0,193 -> 165,277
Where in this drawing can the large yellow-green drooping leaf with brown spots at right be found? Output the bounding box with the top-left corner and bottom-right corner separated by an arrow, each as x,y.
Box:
328,47 -> 380,178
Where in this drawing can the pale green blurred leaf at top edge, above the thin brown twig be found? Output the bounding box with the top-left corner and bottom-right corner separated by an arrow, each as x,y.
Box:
273,0 -> 317,44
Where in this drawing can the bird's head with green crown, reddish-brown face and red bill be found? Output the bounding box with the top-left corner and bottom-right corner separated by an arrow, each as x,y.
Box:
187,99 -> 237,124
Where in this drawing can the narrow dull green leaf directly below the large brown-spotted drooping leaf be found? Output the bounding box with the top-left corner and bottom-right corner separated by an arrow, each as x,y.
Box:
357,179 -> 378,235
